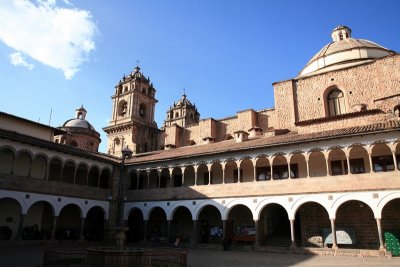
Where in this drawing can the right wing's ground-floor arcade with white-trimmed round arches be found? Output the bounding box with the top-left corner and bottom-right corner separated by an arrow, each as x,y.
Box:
125,191 -> 400,249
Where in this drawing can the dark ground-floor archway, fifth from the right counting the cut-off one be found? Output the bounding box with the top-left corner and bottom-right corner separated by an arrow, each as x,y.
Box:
226,205 -> 256,247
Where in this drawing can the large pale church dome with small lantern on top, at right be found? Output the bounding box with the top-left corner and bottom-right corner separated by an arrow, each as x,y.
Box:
299,26 -> 395,76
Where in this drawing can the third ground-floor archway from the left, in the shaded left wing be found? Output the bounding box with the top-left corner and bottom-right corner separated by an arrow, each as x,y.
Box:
56,204 -> 81,240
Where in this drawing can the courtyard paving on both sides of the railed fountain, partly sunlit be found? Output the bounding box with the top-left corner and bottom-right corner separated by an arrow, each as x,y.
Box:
0,244 -> 400,267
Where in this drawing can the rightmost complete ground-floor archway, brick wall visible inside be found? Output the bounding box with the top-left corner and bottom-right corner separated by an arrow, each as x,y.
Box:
335,200 -> 379,249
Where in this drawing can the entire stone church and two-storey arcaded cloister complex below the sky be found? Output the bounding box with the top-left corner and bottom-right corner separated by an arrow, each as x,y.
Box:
0,26 -> 400,254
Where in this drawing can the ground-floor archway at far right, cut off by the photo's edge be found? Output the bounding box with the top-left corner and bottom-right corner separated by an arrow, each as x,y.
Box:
381,198 -> 400,256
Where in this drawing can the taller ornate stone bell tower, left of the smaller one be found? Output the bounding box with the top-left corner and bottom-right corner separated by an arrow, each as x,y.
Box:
103,66 -> 160,156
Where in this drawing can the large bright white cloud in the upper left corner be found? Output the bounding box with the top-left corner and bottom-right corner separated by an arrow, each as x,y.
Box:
0,0 -> 97,79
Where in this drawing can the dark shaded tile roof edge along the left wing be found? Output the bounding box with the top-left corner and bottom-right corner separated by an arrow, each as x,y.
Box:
0,129 -> 121,164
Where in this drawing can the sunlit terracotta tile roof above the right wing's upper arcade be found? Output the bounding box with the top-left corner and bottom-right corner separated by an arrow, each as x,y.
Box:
127,121 -> 400,164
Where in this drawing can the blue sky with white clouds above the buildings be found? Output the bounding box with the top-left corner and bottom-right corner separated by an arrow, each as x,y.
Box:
0,0 -> 400,152
